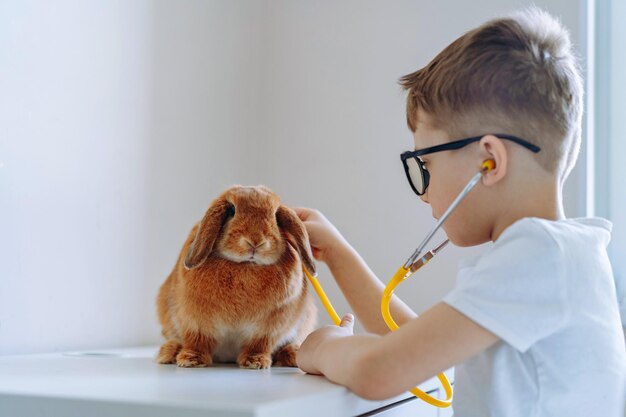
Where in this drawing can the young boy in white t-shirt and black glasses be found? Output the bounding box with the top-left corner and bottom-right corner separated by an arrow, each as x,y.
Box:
296,8 -> 626,417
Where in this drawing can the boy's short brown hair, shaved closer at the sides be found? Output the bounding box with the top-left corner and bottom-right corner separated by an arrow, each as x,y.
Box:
400,7 -> 583,180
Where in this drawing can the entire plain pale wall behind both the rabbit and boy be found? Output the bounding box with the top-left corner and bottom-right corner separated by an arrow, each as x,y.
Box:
0,0 -> 582,354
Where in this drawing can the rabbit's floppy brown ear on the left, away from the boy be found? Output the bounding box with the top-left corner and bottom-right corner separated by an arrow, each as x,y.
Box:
185,197 -> 232,269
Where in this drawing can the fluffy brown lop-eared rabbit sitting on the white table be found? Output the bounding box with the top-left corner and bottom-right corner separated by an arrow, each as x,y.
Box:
157,186 -> 317,369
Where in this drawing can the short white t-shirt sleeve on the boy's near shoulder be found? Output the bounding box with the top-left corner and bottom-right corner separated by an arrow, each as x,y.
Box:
443,220 -> 569,352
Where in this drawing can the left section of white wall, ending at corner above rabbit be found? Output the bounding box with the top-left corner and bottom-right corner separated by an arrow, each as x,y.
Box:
0,0 -> 260,354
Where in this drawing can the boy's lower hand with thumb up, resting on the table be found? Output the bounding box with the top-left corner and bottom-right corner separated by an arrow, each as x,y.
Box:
296,314 -> 354,375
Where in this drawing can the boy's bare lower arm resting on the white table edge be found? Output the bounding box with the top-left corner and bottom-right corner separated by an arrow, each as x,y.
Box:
308,302 -> 499,400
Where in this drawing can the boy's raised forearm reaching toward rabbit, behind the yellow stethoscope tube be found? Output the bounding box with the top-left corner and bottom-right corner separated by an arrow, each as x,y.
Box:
326,242 -> 417,335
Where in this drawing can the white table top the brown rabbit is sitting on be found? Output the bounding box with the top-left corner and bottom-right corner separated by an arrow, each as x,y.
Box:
0,346 -> 452,417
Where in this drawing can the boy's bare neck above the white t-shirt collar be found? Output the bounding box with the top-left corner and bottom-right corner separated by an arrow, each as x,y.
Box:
491,181 -> 565,242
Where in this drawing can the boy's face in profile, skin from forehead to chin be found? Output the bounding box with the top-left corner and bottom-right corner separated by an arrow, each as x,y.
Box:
413,111 -> 491,246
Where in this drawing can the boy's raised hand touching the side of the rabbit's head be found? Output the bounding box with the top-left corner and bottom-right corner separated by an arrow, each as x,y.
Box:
292,207 -> 345,263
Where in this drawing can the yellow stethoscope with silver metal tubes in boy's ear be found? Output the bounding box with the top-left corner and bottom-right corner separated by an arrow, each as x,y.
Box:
303,159 -> 495,408
